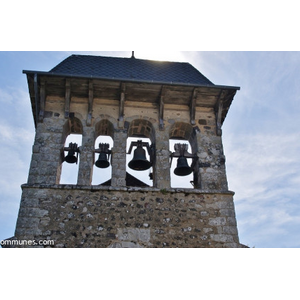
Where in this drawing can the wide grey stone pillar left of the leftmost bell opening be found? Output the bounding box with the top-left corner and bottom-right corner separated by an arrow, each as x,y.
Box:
28,118 -> 64,184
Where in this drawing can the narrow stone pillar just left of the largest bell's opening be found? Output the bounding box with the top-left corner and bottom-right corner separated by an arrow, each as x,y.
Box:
111,130 -> 127,187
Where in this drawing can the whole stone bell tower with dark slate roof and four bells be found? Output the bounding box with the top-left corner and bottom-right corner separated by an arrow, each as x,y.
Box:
14,55 -> 241,247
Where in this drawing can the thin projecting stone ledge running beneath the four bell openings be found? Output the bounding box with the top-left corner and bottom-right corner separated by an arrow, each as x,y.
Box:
21,184 -> 235,196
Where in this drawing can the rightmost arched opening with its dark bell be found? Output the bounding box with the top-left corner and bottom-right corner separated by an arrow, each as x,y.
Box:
169,122 -> 198,188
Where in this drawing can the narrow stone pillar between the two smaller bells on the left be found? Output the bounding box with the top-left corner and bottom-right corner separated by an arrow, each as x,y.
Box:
77,127 -> 95,185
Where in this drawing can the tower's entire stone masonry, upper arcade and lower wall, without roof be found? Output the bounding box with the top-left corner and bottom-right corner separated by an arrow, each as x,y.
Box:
15,97 -> 240,248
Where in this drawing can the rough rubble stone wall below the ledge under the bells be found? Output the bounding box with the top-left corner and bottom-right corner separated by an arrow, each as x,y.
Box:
15,185 -> 240,248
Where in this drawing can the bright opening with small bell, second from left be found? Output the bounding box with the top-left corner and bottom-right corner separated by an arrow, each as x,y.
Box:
92,135 -> 114,186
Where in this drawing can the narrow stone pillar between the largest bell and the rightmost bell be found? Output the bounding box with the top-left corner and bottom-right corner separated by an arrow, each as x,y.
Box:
153,130 -> 171,189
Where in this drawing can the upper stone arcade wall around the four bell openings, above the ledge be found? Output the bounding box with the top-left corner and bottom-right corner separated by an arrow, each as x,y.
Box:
28,97 -> 228,191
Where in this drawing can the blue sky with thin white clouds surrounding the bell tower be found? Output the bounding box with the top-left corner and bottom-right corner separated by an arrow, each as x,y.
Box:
0,51 -> 300,248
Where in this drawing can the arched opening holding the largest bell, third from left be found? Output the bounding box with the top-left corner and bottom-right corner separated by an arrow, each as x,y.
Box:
126,119 -> 155,187
